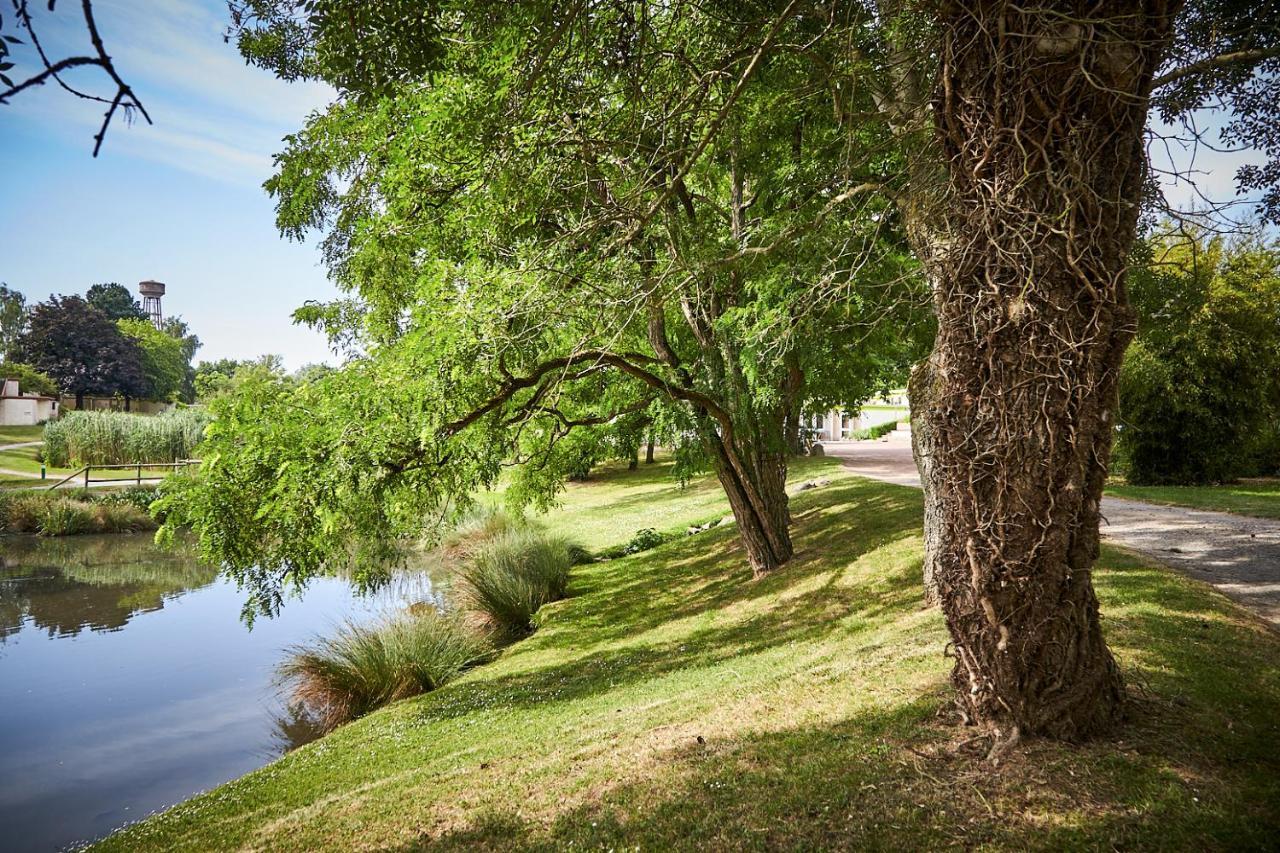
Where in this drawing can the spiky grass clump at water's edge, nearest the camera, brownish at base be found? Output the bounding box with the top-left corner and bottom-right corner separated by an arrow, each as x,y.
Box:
276,610 -> 492,731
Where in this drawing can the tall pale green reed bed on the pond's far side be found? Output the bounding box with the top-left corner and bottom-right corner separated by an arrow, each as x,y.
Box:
45,409 -> 210,467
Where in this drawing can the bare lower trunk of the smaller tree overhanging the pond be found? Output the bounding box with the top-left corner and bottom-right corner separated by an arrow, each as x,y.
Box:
713,439 -> 792,578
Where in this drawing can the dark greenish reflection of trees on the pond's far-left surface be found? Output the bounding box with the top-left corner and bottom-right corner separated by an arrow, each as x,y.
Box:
0,535 -> 218,639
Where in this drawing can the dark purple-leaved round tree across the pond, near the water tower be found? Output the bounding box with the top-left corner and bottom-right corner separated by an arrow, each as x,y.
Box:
18,296 -> 145,409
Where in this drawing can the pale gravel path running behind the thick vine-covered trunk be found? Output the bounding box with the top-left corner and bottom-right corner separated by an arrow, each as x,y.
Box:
824,433 -> 1280,625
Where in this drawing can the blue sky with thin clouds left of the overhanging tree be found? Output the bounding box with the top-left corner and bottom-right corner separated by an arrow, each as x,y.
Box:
0,0 -> 335,368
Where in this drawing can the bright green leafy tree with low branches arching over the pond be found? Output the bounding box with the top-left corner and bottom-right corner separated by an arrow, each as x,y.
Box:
154,4 -> 915,601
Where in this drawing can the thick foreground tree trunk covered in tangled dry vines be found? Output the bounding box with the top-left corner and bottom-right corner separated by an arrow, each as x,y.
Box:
911,0 -> 1172,743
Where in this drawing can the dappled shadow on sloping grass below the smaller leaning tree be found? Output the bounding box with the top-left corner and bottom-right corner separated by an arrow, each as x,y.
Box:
422,484 -> 923,720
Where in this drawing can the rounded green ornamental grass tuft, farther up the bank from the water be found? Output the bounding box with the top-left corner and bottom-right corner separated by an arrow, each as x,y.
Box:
456,528 -> 573,638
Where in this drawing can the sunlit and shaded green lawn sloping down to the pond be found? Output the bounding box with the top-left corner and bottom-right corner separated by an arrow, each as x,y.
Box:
101,462 -> 1280,850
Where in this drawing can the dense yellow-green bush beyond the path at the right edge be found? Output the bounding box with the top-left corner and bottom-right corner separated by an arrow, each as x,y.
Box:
1116,234 -> 1280,485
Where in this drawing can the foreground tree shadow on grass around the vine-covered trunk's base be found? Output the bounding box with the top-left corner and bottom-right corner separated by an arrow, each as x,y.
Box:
399,676 -> 1280,850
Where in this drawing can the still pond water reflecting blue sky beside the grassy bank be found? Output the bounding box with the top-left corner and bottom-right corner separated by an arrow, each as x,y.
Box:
0,535 -> 436,852
